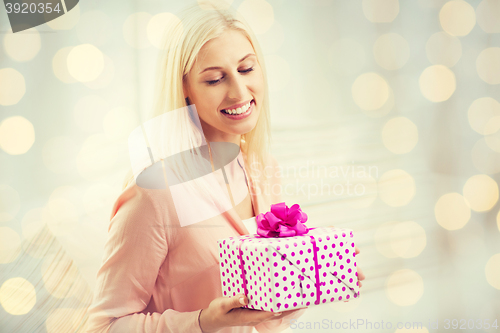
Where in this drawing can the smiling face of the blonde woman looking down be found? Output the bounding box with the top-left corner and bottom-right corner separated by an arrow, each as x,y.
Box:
184,30 -> 264,144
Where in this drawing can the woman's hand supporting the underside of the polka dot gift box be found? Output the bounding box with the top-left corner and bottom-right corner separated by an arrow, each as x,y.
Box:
200,294 -> 300,333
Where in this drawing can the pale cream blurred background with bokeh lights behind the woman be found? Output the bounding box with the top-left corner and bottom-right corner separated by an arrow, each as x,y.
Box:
0,0 -> 500,333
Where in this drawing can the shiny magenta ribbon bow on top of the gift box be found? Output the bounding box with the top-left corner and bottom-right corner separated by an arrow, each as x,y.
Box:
256,202 -> 309,237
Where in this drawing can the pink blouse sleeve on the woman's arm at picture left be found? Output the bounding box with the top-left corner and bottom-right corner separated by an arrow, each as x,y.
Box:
87,185 -> 202,333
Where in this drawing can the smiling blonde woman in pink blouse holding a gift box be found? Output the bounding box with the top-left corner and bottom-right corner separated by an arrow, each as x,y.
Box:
88,3 -> 361,333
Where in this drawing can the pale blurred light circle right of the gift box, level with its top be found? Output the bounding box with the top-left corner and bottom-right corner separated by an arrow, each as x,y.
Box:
390,221 -> 427,258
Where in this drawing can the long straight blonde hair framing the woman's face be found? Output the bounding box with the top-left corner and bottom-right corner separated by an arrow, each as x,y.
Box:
123,4 -> 270,188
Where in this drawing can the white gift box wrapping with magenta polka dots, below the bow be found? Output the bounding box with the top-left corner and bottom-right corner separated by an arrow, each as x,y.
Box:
218,228 -> 359,312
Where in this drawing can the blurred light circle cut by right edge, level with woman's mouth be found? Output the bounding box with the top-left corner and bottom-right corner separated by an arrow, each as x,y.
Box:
468,97 -> 500,135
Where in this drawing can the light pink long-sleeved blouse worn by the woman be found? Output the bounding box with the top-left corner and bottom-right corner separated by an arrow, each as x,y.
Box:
87,152 -> 305,333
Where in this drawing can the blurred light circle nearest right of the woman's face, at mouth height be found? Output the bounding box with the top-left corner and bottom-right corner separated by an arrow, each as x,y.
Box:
352,73 -> 389,111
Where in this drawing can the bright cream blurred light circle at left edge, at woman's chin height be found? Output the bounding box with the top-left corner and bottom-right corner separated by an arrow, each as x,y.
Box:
0,116 -> 35,155
